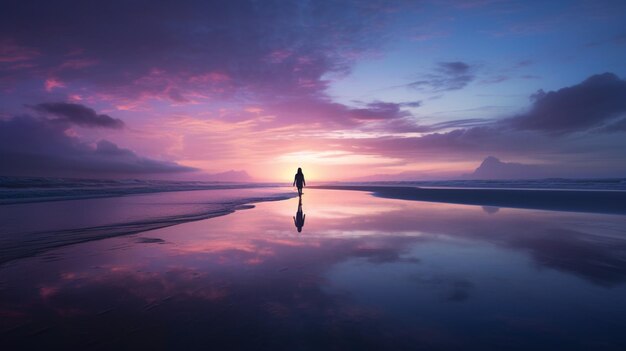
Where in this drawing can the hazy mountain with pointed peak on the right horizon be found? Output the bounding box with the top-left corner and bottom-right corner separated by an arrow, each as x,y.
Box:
463,156 -> 557,179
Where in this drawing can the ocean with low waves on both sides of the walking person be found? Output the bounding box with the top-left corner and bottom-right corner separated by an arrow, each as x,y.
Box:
0,177 -> 626,264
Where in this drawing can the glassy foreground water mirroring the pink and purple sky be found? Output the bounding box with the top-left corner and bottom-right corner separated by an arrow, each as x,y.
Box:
0,190 -> 626,350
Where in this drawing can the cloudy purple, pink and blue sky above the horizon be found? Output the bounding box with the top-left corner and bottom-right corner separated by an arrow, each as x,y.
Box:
0,0 -> 626,182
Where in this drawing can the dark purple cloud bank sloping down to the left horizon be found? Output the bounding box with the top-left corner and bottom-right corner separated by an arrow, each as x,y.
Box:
0,115 -> 195,177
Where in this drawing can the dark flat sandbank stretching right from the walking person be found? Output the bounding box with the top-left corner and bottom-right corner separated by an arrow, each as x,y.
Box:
310,185 -> 626,215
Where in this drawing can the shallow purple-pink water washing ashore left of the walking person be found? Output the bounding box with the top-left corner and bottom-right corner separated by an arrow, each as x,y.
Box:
0,188 -> 295,264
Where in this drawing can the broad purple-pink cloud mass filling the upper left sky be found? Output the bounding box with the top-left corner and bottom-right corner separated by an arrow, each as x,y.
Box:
0,0 -> 406,102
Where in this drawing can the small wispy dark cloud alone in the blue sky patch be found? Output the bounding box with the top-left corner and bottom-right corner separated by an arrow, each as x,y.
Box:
407,61 -> 474,92
